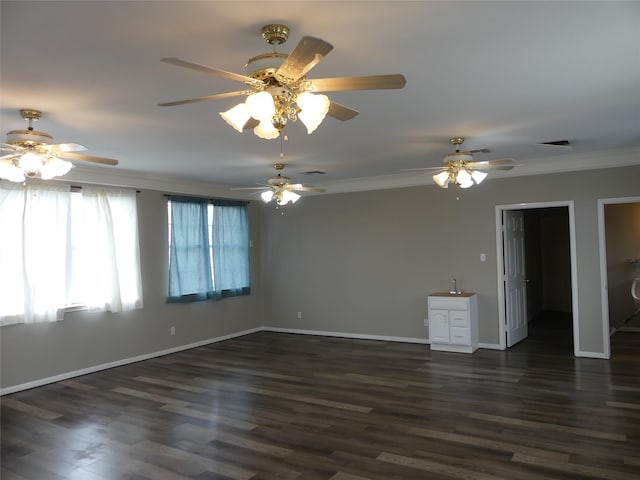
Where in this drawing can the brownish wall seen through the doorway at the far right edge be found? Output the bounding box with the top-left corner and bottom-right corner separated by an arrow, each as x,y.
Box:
604,203 -> 640,327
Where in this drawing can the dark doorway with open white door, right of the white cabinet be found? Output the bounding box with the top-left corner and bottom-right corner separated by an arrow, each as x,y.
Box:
496,201 -> 580,355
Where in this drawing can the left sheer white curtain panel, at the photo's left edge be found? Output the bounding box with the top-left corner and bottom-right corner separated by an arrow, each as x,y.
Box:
0,181 -> 70,325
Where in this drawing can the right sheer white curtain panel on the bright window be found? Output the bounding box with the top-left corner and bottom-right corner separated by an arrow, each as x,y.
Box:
82,187 -> 142,312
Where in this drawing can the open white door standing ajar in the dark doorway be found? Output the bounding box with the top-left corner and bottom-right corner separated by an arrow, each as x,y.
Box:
502,210 -> 528,347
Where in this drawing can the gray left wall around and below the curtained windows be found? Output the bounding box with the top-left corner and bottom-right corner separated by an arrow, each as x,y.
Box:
0,190 -> 263,388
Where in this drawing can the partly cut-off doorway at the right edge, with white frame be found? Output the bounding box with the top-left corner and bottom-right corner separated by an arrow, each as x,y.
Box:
598,197 -> 640,358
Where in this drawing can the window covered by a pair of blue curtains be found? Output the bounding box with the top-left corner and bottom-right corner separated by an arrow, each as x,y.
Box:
167,196 -> 251,303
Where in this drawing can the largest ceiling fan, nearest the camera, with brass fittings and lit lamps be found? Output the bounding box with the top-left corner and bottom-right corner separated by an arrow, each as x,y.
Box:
158,24 -> 406,139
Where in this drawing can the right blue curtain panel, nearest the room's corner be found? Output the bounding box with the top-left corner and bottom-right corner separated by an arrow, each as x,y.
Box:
213,200 -> 251,298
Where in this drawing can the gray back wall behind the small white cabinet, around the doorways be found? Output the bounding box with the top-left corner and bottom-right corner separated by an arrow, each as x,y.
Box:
261,166 -> 640,353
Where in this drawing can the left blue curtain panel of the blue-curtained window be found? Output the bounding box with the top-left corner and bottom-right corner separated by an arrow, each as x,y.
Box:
167,196 -> 214,303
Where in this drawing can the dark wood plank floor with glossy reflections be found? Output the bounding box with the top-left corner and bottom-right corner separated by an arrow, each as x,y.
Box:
1,332 -> 640,480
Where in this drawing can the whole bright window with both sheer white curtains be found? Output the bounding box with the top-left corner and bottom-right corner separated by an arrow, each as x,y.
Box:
0,181 -> 143,325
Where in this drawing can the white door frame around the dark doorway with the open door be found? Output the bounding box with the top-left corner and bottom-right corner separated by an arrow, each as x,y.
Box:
496,200 -> 581,356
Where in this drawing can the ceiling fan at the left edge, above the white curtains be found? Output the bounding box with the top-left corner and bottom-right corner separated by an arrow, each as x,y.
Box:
0,109 -> 118,182
